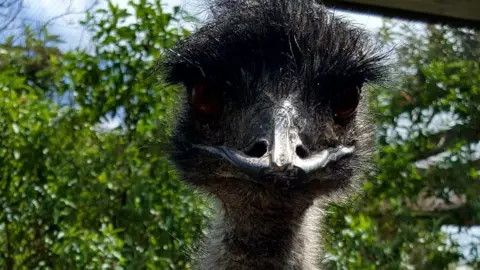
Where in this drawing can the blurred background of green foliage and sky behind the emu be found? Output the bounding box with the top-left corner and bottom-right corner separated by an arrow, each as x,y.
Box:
0,0 -> 480,270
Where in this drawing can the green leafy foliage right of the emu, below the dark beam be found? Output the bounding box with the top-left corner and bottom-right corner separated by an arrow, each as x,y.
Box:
327,22 -> 480,269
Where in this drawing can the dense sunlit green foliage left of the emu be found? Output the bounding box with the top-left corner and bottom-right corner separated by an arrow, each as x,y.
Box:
0,1 -> 207,269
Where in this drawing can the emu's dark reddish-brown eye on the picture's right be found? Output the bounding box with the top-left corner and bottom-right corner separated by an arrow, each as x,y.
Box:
332,87 -> 360,120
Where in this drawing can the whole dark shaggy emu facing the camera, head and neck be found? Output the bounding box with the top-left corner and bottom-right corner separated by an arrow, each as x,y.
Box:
162,0 -> 384,270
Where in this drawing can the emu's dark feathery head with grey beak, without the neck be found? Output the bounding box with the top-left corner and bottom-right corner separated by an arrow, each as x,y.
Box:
164,0 -> 382,197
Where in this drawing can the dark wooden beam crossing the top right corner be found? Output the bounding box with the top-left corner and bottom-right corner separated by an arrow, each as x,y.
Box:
317,0 -> 480,28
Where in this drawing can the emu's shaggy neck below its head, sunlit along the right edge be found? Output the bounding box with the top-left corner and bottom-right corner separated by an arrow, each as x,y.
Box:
202,187 -> 320,270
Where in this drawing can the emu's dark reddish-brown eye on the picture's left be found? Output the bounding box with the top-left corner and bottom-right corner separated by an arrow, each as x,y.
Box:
188,83 -> 222,116
